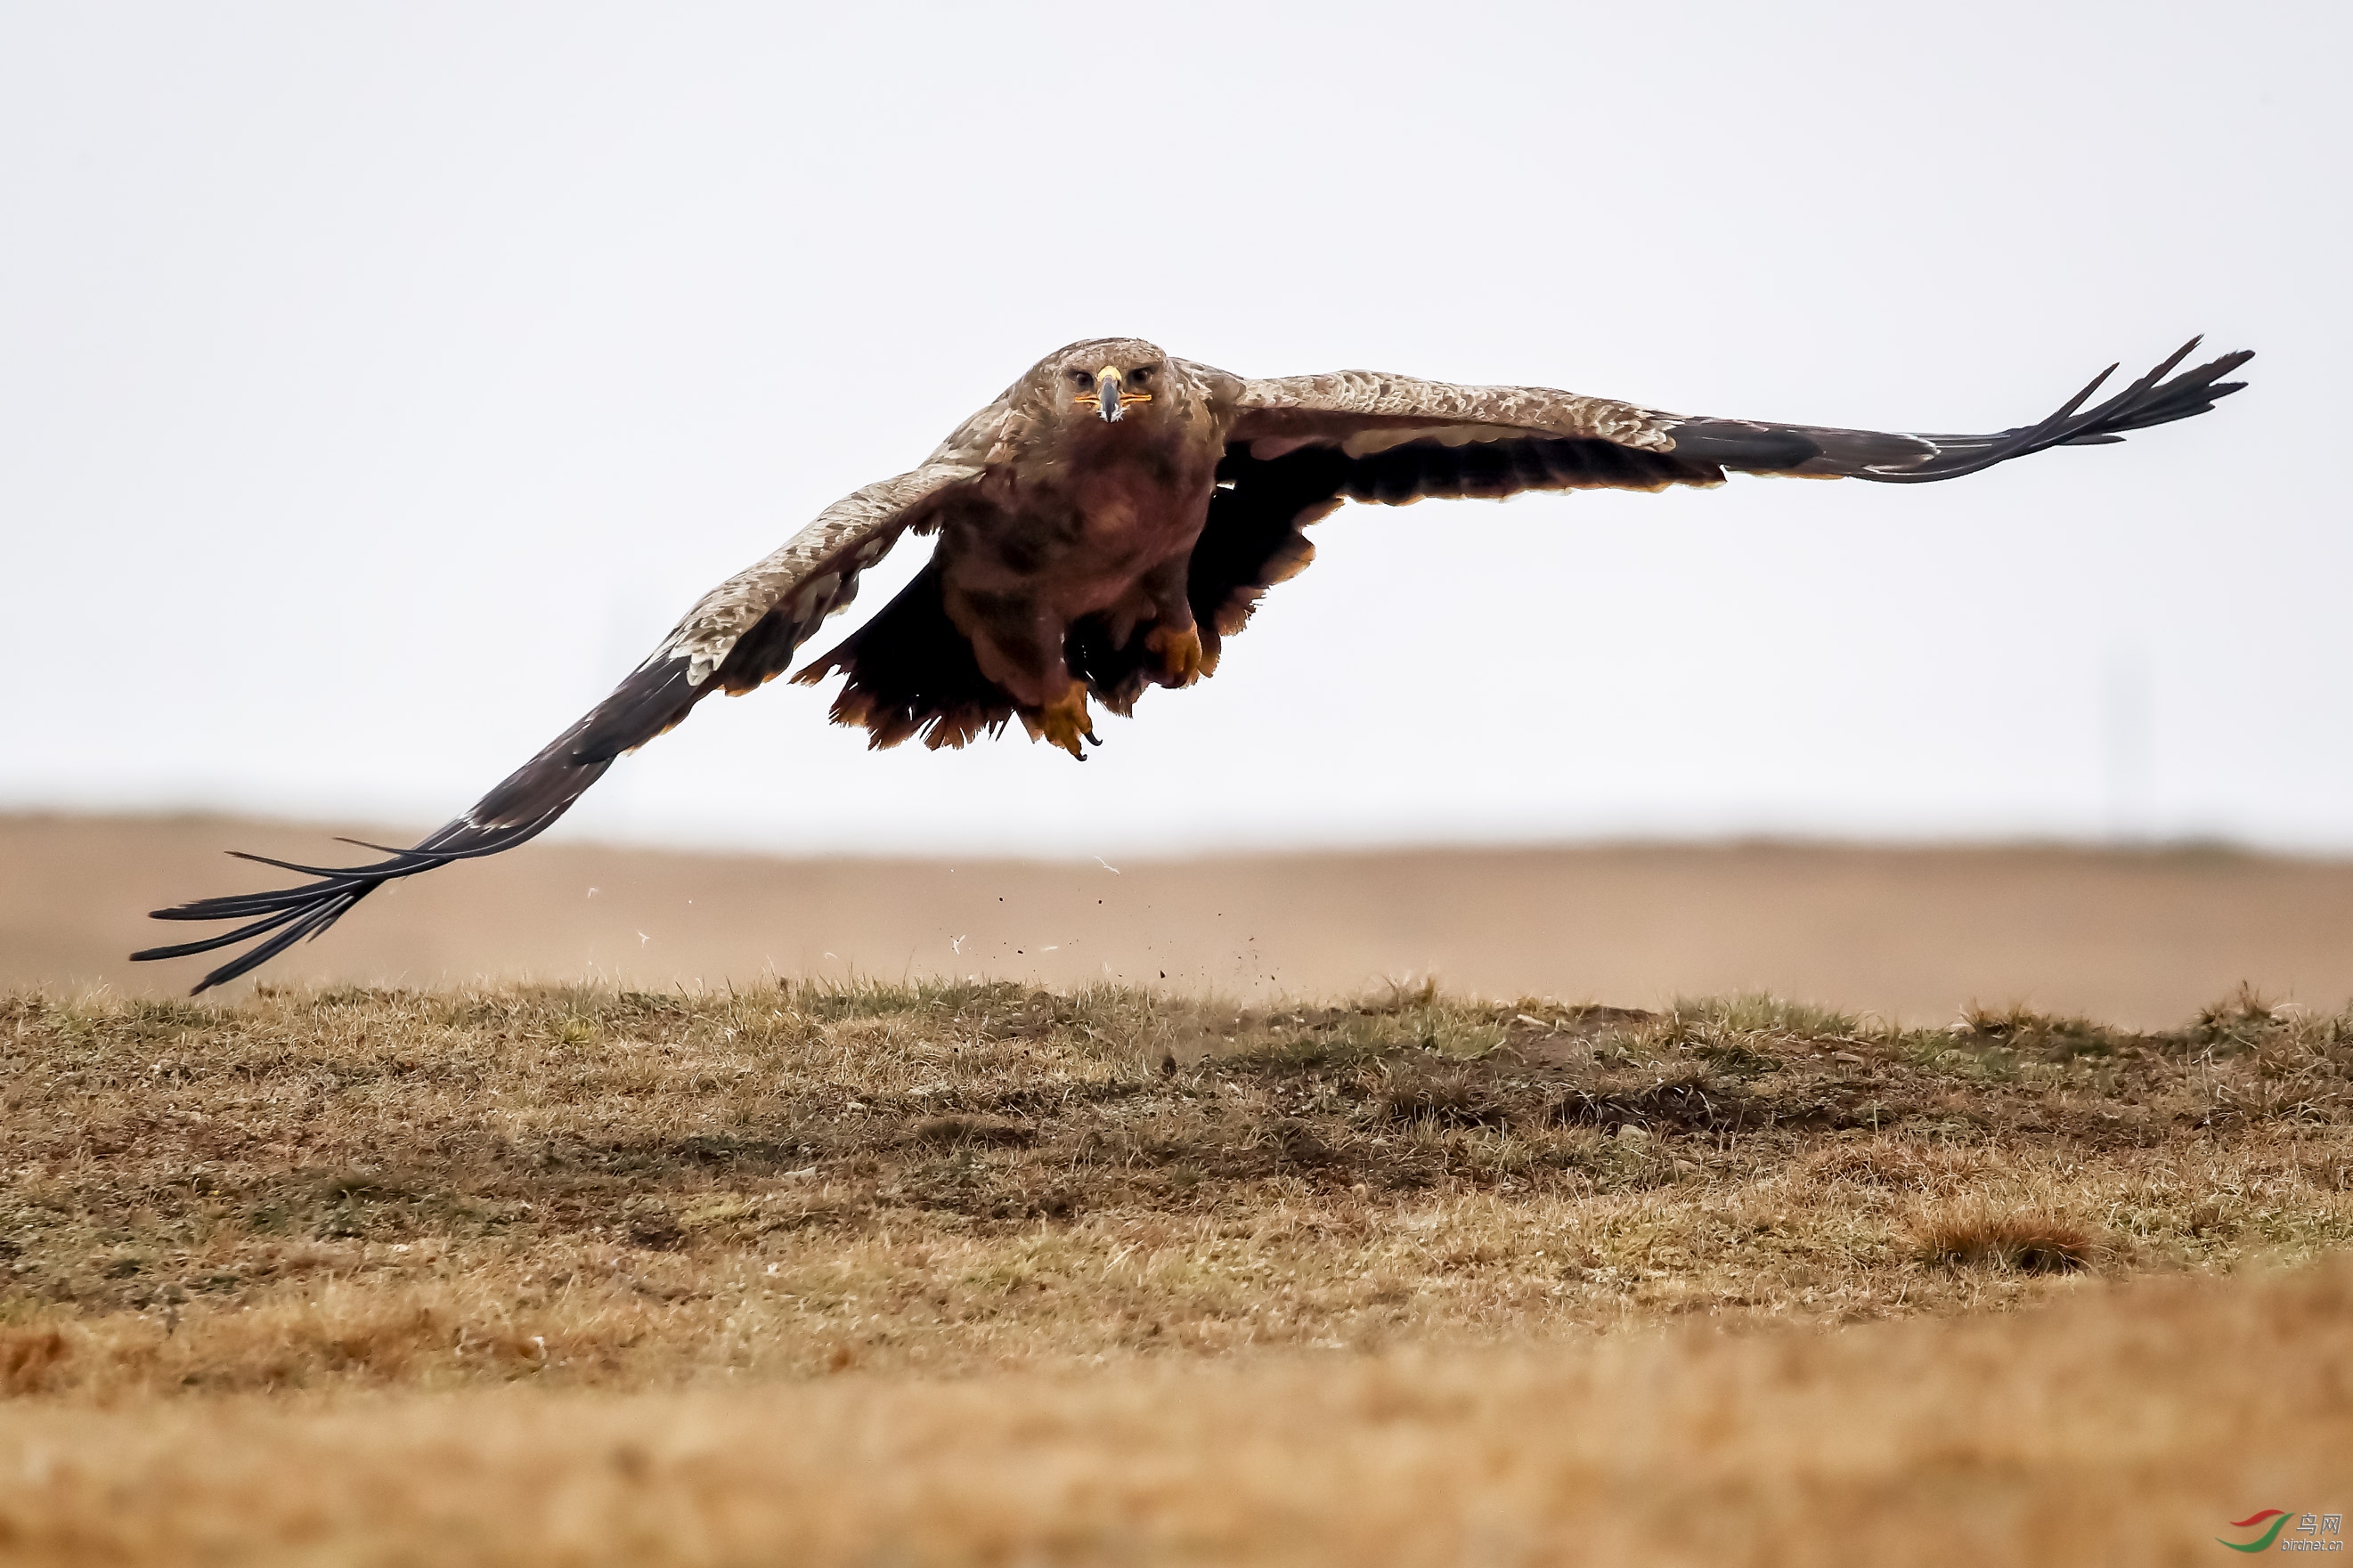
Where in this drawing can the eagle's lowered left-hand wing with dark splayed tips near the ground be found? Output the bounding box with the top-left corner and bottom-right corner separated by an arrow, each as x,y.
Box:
132,423 -> 1002,995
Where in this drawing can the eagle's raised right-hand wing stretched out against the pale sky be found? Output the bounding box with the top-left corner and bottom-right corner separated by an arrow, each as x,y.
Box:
1191,338 -> 2254,658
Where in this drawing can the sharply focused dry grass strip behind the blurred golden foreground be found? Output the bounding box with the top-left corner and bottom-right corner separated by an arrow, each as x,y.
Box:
0,985 -> 2353,1399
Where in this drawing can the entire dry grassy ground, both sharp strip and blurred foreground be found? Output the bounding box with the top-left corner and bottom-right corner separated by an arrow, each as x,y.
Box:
0,985 -> 2353,1565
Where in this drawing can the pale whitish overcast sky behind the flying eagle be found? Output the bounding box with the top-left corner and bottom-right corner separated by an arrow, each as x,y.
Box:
0,0 -> 2353,856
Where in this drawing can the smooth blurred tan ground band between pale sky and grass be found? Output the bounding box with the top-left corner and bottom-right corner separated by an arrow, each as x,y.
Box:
13,816 -> 2353,1028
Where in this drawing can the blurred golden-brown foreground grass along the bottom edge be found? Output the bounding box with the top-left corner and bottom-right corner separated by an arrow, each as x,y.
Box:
0,1264 -> 2353,1568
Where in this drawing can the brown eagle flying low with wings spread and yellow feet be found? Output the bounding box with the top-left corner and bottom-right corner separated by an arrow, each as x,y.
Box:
132,338 -> 2251,992
